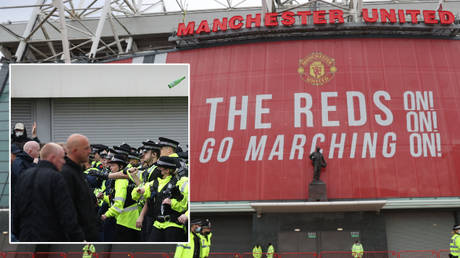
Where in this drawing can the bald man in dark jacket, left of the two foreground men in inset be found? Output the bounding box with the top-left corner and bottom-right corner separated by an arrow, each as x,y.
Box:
12,143 -> 85,242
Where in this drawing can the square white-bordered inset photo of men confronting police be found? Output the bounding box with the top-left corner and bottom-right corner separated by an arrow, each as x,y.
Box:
10,64 -> 190,244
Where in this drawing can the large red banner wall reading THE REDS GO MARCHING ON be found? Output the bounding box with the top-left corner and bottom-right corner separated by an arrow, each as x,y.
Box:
167,39 -> 460,201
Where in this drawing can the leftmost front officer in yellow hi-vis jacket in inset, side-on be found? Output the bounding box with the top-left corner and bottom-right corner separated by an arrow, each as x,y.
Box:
101,154 -> 140,242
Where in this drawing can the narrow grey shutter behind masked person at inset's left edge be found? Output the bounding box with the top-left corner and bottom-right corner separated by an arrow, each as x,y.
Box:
11,98 -> 35,137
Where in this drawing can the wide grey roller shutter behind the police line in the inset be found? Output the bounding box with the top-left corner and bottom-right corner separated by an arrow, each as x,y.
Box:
52,97 -> 188,147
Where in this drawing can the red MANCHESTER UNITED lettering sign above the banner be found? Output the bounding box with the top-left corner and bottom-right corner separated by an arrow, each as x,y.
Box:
177,9 -> 455,37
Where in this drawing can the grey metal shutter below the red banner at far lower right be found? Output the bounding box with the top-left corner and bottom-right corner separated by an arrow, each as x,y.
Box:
385,211 -> 454,251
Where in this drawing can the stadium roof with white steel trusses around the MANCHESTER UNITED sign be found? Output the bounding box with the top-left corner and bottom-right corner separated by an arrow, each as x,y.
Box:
0,0 -> 460,62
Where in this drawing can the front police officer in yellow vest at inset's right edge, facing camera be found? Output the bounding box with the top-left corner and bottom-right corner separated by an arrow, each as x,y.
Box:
144,156 -> 188,242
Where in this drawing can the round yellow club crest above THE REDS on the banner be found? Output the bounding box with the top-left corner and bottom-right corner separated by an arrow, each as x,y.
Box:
297,52 -> 337,86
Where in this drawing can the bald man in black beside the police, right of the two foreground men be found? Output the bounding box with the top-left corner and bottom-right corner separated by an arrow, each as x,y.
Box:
62,134 -> 100,242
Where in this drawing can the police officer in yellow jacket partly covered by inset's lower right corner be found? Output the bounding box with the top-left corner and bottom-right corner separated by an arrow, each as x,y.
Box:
174,219 -> 202,258
